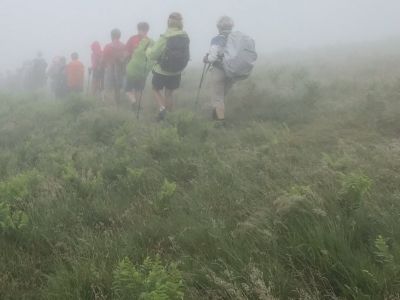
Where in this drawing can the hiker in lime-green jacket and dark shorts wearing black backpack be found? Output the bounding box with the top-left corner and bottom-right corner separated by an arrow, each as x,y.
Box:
147,12 -> 190,120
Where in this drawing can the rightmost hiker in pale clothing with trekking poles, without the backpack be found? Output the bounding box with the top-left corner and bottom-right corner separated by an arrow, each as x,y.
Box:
204,16 -> 234,120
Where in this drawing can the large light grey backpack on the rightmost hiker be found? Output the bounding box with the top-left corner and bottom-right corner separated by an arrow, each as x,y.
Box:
223,31 -> 258,79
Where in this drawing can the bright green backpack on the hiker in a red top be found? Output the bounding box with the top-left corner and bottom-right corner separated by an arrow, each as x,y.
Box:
126,37 -> 154,80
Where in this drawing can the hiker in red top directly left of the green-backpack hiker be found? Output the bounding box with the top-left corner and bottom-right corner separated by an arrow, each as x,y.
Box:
103,29 -> 126,104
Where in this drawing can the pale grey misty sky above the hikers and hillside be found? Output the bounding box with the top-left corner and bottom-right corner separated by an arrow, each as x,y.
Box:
0,0 -> 400,71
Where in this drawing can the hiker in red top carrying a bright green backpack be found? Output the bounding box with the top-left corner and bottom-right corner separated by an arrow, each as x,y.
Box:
125,22 -> 153,105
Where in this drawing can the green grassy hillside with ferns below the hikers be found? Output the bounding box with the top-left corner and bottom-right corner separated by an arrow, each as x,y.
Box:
0,46 -> 400,299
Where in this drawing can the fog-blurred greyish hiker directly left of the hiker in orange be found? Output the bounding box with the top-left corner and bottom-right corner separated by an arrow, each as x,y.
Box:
47,56 -> 67,98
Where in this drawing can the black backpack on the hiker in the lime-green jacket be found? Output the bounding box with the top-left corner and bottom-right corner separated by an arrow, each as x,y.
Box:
158,34 -> 190,73
